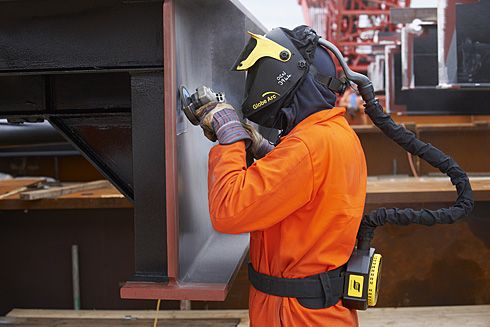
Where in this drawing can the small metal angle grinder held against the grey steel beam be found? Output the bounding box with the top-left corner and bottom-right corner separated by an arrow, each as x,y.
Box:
179,85 -> 226,125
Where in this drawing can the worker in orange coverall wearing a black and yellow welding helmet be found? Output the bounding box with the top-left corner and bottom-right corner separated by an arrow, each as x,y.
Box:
196,26 -> 366,327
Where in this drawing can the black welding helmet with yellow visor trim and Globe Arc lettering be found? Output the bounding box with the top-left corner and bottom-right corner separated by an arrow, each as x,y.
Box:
233,26 -> 346,128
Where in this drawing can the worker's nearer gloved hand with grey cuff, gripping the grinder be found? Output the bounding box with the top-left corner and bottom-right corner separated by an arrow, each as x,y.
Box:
196,103 -> 251,146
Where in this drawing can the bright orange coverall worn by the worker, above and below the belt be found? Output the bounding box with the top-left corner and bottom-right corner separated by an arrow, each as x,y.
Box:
208,108 -> 367,327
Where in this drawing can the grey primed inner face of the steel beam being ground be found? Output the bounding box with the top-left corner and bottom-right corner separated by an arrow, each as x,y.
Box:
175,0 -> 263,282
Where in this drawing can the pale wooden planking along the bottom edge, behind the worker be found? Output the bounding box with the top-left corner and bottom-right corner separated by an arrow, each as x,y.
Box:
4,305 -> 490,327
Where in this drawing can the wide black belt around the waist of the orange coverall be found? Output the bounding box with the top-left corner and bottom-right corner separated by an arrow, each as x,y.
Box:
248,263 -> 345,309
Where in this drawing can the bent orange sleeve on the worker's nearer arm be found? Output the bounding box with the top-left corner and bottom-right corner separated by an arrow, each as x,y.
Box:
208,137 -> 313,234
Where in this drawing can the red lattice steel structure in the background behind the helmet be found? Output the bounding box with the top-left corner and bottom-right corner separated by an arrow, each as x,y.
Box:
298,0 -> 410,72
